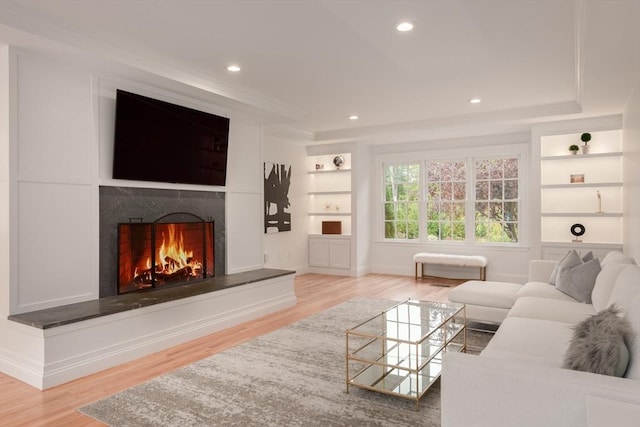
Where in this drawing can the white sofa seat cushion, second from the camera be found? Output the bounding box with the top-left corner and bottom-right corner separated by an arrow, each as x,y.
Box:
507,297 -> 596,325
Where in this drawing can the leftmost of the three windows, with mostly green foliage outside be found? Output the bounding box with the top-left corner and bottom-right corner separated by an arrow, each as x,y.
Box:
384,163 -> 420,239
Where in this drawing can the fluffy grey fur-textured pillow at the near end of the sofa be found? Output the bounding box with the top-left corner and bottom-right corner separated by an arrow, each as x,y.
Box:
562,305 -> 633,377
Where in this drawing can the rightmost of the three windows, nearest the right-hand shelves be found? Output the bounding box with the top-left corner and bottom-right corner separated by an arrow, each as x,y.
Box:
475,159 -> 518,243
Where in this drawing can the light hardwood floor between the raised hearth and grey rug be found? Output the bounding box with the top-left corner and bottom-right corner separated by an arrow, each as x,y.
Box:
0,274 -> 464,427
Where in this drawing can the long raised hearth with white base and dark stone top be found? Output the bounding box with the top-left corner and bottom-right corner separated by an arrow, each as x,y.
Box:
0,269 -> 297,390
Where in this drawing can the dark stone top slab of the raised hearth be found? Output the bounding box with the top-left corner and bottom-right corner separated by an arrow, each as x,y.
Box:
9,268 -> 295,329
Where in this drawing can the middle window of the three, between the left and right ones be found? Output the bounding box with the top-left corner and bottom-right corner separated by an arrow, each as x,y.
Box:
426,161 -> 467,240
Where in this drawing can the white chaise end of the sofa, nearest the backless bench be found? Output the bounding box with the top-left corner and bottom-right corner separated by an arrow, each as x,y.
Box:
448,280 -> 522,323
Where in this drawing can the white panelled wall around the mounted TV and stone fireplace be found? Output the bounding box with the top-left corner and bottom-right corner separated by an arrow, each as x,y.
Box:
0,48 -> 262,314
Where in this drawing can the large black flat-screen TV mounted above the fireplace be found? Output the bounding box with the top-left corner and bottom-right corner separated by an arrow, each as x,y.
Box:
113,90 -> 229,185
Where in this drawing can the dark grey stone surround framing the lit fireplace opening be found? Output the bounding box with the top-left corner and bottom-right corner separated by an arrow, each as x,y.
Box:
99,187 -> 226,298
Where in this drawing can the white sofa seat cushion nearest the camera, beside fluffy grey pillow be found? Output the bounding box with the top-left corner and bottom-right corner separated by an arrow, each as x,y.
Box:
481,318 -> 573,368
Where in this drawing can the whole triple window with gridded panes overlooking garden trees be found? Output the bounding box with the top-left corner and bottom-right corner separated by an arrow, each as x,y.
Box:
383,152 -> 520,244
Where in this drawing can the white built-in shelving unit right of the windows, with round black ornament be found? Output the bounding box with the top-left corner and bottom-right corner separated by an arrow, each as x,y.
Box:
540,130 -> 623,258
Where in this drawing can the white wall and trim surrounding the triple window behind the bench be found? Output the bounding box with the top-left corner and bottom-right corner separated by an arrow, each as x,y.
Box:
369,133 -> 539,283
